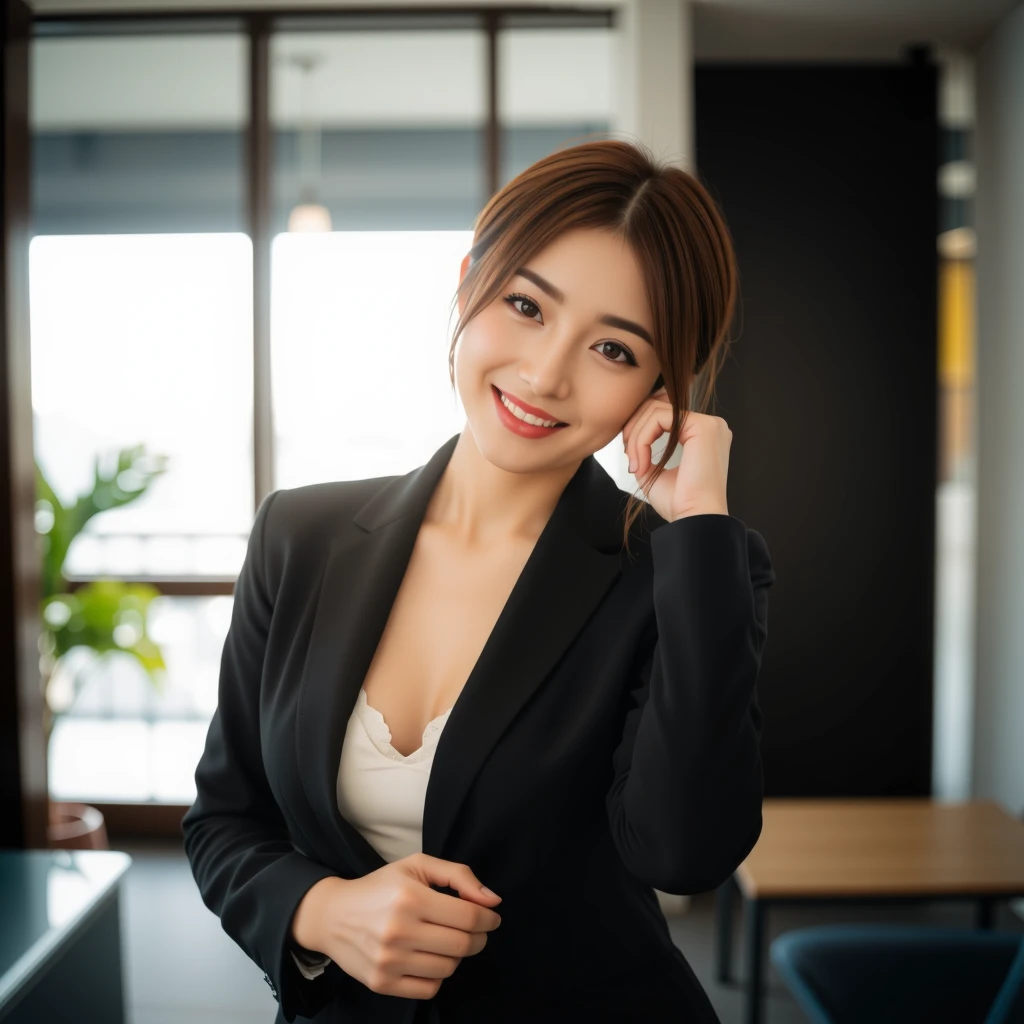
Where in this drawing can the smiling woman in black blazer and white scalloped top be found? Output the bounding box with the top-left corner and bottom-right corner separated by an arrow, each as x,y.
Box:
182,140 -> 774,1024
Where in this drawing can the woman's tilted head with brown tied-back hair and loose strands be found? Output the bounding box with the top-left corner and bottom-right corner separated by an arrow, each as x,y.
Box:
449,140 -> 738,548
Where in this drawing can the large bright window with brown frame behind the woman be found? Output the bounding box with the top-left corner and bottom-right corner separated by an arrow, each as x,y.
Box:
30,8 -> 613,805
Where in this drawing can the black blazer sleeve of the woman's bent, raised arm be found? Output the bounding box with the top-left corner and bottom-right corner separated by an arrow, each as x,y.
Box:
605,514 -> 775,895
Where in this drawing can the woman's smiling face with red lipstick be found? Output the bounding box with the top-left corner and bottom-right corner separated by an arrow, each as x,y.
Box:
455,228 -> 660,472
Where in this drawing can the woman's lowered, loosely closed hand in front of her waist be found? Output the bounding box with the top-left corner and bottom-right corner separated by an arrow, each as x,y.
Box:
292,853 -> 502,999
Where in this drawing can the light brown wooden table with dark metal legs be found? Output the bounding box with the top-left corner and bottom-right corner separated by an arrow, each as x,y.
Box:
716,798 -> 1024,1024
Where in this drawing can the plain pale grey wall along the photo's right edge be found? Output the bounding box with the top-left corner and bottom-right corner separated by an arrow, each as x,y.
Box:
972,3 -> 1024,814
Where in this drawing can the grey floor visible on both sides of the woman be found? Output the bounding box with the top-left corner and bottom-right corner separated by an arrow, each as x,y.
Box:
112,842 -> 1024,1024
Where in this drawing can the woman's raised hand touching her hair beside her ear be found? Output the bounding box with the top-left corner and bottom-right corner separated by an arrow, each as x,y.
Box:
623,388 -> 732,522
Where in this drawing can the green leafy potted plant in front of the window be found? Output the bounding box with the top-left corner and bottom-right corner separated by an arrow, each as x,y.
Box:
36,445 -> 168,849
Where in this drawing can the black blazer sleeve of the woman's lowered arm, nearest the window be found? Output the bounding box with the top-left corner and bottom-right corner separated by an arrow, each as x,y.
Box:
181,490 -> 335,1022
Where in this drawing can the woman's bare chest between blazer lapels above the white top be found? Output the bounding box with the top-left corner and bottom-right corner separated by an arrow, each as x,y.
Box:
362,530 -> 532,757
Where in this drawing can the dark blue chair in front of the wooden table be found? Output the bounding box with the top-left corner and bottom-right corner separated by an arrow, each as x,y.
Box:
769,924 -> 1024,1024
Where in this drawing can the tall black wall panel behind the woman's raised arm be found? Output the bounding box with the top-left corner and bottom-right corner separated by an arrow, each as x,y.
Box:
695,62 -> 938,797
